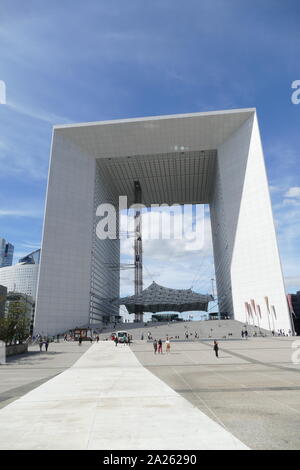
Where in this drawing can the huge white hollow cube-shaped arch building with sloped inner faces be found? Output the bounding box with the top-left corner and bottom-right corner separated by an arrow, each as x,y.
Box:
35,109 -> 290,334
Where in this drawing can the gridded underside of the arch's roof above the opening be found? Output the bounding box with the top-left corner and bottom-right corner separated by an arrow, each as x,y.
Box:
101,150 -> 216,206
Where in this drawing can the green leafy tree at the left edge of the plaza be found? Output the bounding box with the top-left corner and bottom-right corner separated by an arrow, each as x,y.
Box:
0,301 -> 30,345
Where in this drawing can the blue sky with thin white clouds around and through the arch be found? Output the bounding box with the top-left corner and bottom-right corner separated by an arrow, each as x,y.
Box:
0,0 -> 300,316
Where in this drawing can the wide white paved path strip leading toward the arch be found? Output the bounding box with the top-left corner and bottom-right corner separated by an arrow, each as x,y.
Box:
0,342 -> 247,450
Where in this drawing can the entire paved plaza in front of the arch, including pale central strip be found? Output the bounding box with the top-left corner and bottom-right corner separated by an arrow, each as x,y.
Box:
0,337 -> 300,450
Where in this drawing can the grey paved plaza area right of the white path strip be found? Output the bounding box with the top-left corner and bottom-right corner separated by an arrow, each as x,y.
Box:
133,337 -> 300,449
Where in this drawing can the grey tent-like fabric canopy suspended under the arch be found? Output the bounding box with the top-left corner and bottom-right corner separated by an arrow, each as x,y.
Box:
118,281 -> 214,313
